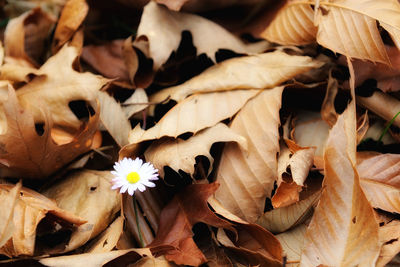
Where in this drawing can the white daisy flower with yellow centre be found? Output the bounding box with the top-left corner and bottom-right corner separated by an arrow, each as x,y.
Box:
111,158 -> 158,196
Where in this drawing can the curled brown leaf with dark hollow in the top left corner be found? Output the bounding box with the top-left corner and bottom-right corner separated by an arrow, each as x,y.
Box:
4,8 -> 55,66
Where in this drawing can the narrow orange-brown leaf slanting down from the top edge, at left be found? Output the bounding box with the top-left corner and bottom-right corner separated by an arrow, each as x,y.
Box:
52,0 -> 89,54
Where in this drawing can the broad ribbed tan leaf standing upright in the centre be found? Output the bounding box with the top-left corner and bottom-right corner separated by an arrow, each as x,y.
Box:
215,87 -> 283,222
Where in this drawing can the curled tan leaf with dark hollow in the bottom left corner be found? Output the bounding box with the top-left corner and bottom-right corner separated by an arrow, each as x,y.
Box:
0,184 -> 86,257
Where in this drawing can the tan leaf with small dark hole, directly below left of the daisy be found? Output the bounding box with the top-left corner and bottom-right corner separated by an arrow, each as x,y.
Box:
43,170 -> 121,252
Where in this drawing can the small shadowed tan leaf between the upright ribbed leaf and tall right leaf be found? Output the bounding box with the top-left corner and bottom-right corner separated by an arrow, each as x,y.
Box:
257,193 -> 320,234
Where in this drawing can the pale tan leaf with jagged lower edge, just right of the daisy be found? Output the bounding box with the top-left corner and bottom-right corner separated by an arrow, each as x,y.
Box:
144,123 -> 247,177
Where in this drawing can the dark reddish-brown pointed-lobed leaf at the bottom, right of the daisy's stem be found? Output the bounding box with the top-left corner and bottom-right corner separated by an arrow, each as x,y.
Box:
148,183 -> 233,266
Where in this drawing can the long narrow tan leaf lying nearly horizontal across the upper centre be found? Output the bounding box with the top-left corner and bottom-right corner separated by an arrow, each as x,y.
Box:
150,51 -> 322,102
